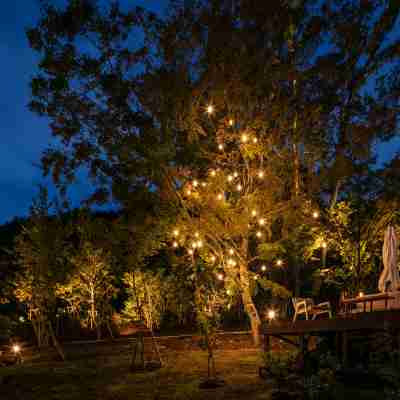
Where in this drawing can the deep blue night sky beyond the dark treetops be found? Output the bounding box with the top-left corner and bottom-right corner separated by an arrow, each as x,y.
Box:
0,0 -> 398,224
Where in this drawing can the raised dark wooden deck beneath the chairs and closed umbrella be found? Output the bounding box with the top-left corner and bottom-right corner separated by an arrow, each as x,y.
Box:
262,310 -> 400,364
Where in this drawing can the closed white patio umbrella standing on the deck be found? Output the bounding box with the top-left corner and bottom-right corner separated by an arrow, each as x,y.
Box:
378,226 -> 400,292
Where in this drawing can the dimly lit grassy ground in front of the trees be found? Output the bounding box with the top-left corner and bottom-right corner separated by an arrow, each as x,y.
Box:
0,341 -> 270,400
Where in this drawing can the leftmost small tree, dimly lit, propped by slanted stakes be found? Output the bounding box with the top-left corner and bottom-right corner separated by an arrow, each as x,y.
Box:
14,189 -> 65,358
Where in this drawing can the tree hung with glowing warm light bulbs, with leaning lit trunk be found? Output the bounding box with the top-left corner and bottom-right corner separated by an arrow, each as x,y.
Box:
172,109 -> 294,342
